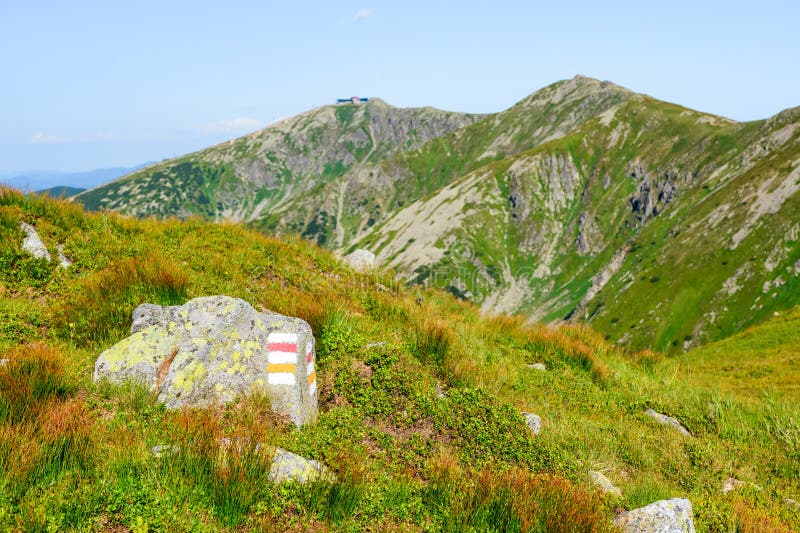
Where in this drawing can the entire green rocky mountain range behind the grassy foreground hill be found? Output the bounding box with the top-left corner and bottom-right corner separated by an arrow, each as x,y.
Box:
76,76 -> 800,351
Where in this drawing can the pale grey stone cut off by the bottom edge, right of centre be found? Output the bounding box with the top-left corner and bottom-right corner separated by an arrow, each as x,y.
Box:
614,498 -> 694,533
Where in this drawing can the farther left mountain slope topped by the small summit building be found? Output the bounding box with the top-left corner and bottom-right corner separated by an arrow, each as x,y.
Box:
77,99 -> 478,239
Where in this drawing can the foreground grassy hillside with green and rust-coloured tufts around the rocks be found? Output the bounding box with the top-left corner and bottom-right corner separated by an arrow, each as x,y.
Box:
0,189 -> 800,531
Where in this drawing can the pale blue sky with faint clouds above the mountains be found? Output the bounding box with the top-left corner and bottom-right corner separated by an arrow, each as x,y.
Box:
0,0 -> 800,173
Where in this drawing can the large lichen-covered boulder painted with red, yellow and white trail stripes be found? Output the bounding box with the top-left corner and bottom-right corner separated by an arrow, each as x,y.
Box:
94,296 -> 317,426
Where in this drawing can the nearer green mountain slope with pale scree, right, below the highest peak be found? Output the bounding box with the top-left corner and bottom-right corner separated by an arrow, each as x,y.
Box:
356,98 -> 800,350
